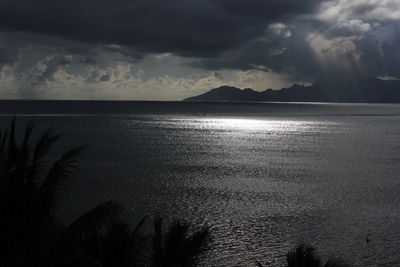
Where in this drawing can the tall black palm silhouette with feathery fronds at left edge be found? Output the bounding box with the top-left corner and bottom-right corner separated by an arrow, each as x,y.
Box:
0,119 -> 82,266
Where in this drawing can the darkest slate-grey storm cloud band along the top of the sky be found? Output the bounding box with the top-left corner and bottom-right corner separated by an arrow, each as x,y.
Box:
0,0 -> 321,57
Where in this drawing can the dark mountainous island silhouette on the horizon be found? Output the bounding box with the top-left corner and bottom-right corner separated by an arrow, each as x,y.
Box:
183,78 -> 400,103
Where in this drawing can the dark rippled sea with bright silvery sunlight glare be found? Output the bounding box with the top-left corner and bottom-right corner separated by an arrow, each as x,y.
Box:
0,102 -> 400,266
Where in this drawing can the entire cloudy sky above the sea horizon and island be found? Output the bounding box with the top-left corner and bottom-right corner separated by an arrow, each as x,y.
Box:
0,0 -> 400,100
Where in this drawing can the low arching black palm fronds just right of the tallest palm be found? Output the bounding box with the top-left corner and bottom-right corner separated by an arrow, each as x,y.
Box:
53,202 -> 147,267
